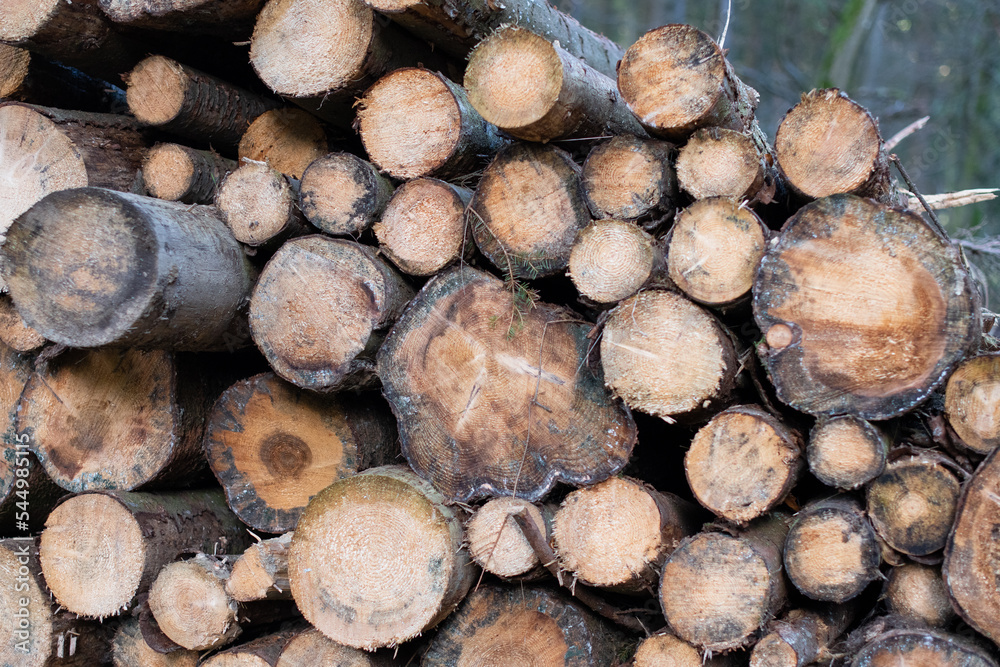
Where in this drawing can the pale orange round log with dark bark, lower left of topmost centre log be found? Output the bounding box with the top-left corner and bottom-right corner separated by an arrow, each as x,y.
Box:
356,67 -> 510,180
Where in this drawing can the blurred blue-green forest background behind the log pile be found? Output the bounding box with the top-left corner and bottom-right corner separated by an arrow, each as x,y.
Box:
552,0 -> 1000,310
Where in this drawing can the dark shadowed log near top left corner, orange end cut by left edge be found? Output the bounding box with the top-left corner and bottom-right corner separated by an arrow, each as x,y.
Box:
0,44 -> 128,113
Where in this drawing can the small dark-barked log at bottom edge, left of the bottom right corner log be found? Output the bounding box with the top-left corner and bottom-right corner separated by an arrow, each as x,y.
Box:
750,604 -> 858,667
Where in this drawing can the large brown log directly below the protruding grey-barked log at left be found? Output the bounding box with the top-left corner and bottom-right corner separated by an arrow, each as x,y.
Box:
17,348 -> 221,491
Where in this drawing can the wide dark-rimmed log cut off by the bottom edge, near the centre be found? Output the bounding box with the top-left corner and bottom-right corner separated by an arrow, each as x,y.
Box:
421,586 -> 624,667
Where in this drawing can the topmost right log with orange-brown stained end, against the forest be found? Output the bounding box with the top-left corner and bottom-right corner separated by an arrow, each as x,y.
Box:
618,24 -> 766,143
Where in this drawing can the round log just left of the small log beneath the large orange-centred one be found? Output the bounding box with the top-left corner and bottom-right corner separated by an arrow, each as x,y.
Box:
684,405 -> 803,524
